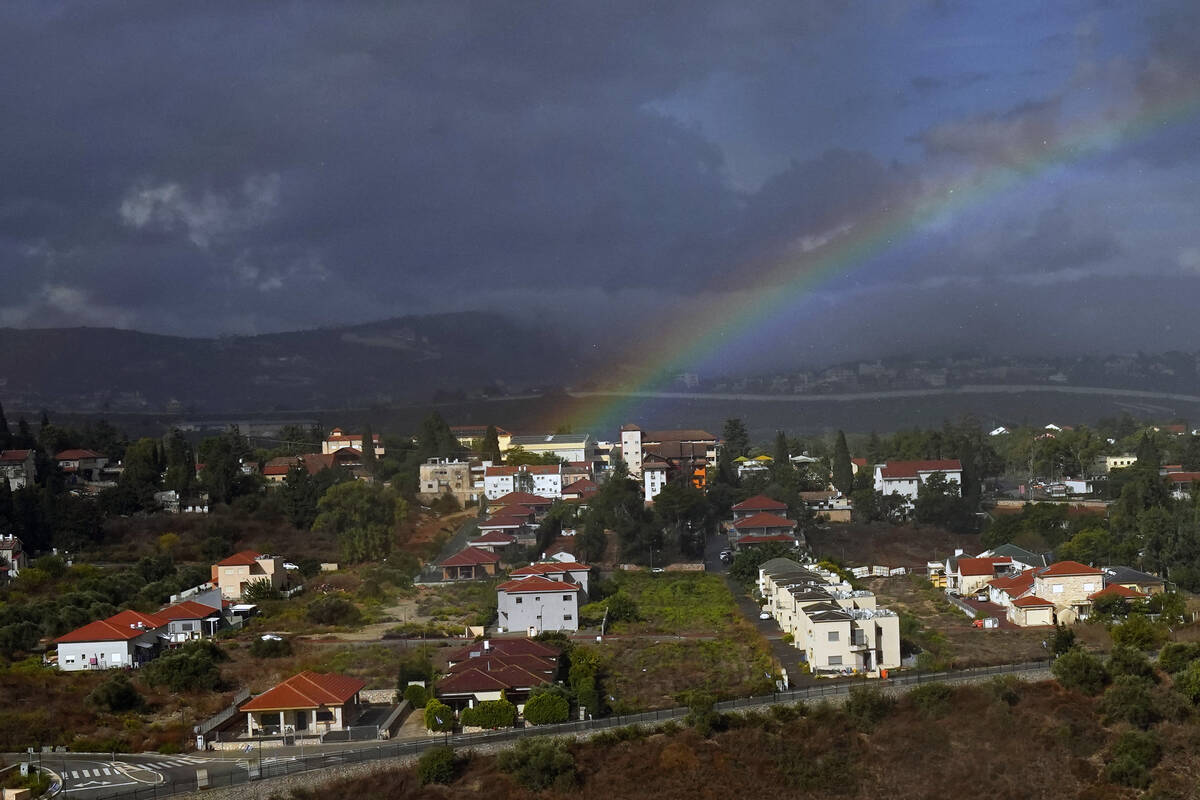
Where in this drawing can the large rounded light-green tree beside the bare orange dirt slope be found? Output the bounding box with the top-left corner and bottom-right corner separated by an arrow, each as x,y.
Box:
313,481 -> 408,563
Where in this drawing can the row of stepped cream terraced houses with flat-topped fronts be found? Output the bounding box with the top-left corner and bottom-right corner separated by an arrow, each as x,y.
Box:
758,559 -> 900,675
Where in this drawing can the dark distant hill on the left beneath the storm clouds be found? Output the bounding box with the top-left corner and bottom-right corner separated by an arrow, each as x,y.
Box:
0,312 -> 580,411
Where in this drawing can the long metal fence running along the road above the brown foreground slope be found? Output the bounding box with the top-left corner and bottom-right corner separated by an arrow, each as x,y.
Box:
77,661 -> 1049,800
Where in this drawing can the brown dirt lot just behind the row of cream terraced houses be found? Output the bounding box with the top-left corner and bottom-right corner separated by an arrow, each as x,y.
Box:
806,523 -> 983,567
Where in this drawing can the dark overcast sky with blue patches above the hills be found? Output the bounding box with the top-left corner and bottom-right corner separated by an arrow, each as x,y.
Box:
0,0 -> 1200,369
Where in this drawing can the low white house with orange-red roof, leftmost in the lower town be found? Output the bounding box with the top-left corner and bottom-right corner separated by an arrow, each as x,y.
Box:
54,610 -> 169,672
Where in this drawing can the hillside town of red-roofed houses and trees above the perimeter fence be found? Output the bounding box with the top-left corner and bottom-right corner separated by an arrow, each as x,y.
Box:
0,413 -> 1200,796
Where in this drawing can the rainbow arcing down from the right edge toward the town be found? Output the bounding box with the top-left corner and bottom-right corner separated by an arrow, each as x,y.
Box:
561,89 -> 1200,437
